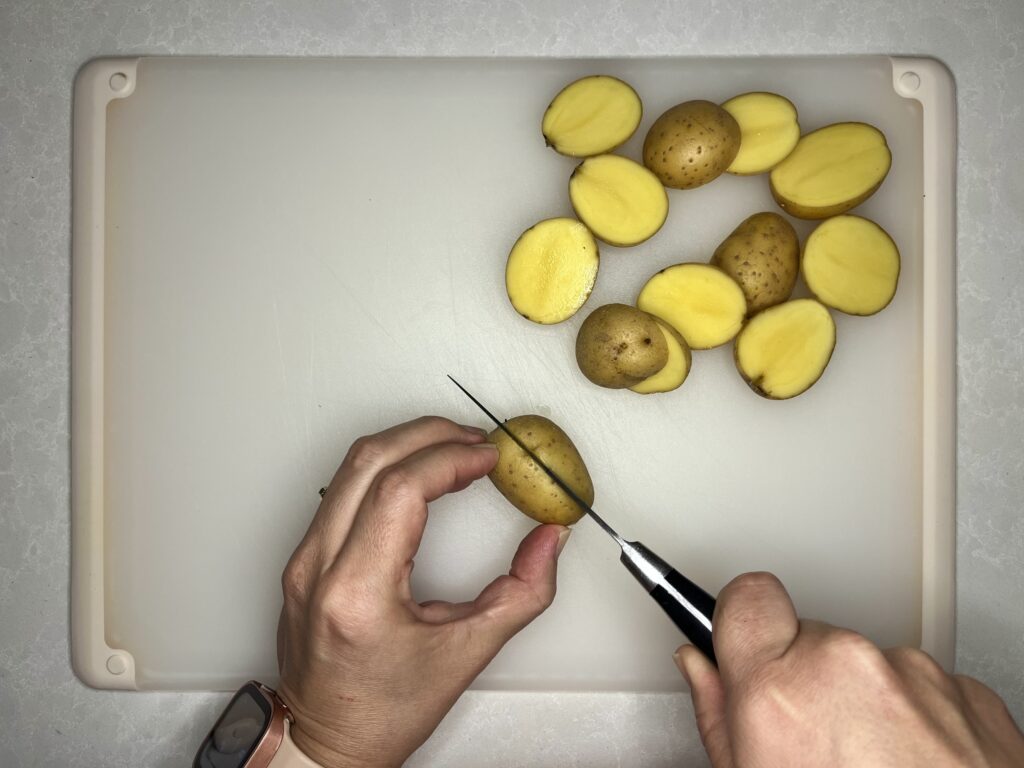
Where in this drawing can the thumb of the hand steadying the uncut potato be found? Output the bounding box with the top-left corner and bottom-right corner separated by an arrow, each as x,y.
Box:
465,525 -> 571,660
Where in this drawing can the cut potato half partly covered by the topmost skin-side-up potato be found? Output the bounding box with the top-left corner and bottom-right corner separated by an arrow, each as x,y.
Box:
722,91 -> 800,175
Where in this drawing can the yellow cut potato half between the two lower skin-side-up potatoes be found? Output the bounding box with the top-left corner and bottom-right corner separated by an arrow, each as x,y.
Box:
637,264 -> 746,349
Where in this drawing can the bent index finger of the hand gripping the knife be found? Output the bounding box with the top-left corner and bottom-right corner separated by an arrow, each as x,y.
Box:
712,572 -> 800,688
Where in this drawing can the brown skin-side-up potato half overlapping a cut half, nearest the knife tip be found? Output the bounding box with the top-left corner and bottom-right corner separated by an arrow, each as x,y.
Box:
577,304 -> 669,389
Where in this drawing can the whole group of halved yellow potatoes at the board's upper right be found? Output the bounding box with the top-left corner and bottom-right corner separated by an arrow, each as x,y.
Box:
505,75 -> 900,399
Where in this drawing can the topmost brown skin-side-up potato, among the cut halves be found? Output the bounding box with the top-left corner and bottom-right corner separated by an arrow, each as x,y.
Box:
643,100 -> 740,189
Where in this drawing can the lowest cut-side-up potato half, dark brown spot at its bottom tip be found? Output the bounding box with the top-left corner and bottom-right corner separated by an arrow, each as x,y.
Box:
733,299 -> 836,400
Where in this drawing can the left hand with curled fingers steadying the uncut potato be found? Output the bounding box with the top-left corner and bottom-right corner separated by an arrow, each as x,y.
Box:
278,418 -> 569,768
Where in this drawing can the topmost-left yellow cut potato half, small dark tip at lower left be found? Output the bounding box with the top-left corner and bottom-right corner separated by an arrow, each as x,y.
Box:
541,75 -> 643,158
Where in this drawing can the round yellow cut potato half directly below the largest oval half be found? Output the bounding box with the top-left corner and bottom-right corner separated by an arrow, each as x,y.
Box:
802,215 -> 900,314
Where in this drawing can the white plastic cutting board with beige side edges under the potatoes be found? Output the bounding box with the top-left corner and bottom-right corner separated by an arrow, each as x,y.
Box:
74,57 -> 954,690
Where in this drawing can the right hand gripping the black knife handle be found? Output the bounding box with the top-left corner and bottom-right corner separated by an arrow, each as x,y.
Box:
676,573 -> 1024,768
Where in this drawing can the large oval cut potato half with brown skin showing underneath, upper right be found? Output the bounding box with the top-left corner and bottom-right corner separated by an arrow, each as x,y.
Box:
770,123 -> 892,219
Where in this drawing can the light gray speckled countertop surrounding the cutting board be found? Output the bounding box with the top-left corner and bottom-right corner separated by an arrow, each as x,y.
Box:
0,0 -> 1024,768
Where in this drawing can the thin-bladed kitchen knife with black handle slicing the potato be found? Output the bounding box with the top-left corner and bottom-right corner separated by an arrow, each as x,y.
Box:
449,375 -> 718,666
